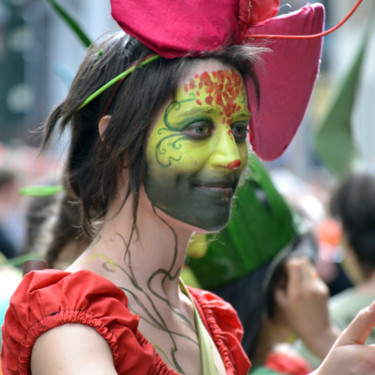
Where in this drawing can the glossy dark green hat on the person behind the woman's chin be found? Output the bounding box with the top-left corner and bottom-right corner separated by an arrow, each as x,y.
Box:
186,155 -> 297,289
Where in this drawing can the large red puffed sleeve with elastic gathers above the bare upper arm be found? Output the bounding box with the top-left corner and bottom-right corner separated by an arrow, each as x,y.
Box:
1,270 -> 155,375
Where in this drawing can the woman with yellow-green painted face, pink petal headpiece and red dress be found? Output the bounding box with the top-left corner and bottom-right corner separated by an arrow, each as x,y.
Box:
1,0 -> 375,375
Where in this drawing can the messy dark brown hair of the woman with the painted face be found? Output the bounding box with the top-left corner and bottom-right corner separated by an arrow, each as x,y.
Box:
42,32 -> 259,235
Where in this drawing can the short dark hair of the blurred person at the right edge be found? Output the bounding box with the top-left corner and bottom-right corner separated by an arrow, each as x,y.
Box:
330,172 -> 375,277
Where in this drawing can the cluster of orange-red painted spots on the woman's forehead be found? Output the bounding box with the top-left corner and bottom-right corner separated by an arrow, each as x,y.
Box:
184,69 -> 246,124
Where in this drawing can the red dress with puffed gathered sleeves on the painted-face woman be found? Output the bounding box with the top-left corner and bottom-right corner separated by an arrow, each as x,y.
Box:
1,270 -> 250,375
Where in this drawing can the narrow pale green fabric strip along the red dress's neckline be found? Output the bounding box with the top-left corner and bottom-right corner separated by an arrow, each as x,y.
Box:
180,280 -> 218,375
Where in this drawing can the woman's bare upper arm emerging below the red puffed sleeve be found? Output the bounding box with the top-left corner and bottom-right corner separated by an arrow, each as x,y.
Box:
31,324 -> 117,375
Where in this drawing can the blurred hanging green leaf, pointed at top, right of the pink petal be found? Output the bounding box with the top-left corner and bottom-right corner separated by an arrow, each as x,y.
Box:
315,28 -> 370,177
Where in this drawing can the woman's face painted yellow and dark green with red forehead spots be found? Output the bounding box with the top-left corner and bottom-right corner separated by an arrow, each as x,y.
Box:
145,62 -> 250,231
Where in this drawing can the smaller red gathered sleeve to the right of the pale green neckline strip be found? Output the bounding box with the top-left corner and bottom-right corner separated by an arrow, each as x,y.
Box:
188,287 -> 251,375
